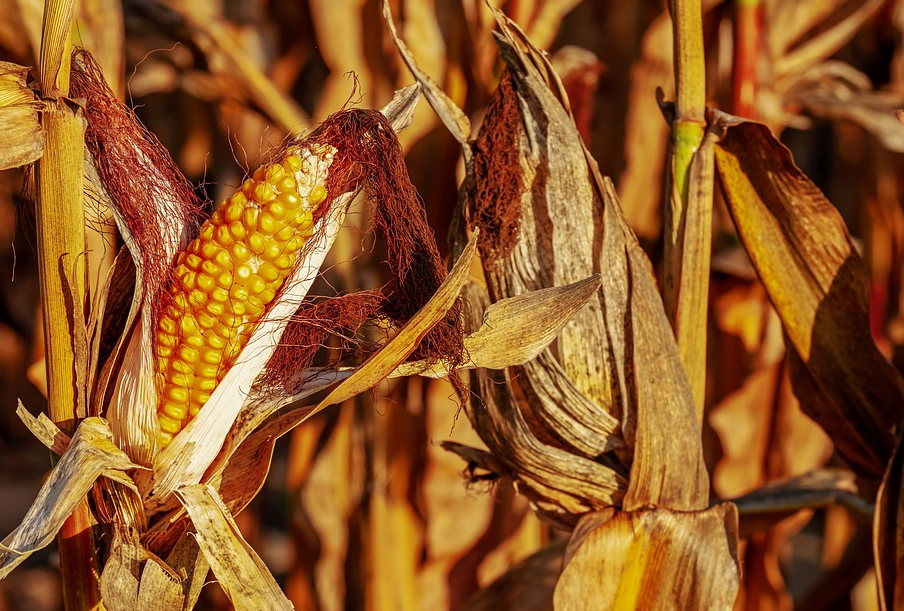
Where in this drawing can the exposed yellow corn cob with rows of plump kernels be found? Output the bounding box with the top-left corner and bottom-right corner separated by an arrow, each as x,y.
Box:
155,144 -> 336,447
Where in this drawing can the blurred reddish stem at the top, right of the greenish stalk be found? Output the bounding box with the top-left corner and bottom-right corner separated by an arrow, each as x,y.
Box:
731,0 -> 762,119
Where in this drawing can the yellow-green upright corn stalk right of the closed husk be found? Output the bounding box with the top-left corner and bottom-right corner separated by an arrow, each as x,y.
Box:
663,0 -> 713,422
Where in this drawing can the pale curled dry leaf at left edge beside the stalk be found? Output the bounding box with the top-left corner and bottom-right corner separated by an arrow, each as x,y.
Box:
0,62 -> 44,170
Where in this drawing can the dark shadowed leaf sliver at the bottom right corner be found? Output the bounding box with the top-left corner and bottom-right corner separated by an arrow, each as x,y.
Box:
873,438 -> 904,611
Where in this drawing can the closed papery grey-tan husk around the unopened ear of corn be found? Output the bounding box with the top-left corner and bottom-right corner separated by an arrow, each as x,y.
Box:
384,3 -> 708,518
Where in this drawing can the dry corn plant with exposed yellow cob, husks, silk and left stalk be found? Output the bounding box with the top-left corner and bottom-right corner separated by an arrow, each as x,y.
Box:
0,2 -> 598,609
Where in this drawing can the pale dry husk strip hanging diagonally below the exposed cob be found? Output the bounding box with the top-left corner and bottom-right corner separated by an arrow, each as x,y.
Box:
176,485 -> 294,611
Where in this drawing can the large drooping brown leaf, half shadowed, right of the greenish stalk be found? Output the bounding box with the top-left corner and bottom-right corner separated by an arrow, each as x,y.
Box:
715,114 -> 904,478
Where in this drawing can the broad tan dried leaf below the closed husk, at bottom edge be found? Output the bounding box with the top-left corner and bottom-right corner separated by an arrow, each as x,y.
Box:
554,503 -> 740,611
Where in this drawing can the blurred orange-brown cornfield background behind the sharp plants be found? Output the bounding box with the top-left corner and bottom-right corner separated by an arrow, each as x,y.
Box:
0,0 -> 904,611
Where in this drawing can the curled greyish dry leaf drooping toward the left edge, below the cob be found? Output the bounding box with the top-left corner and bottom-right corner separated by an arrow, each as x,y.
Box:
0,418 -> 137,579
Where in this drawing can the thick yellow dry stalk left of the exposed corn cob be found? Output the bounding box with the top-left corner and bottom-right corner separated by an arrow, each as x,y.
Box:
36,0 -> 102,611
